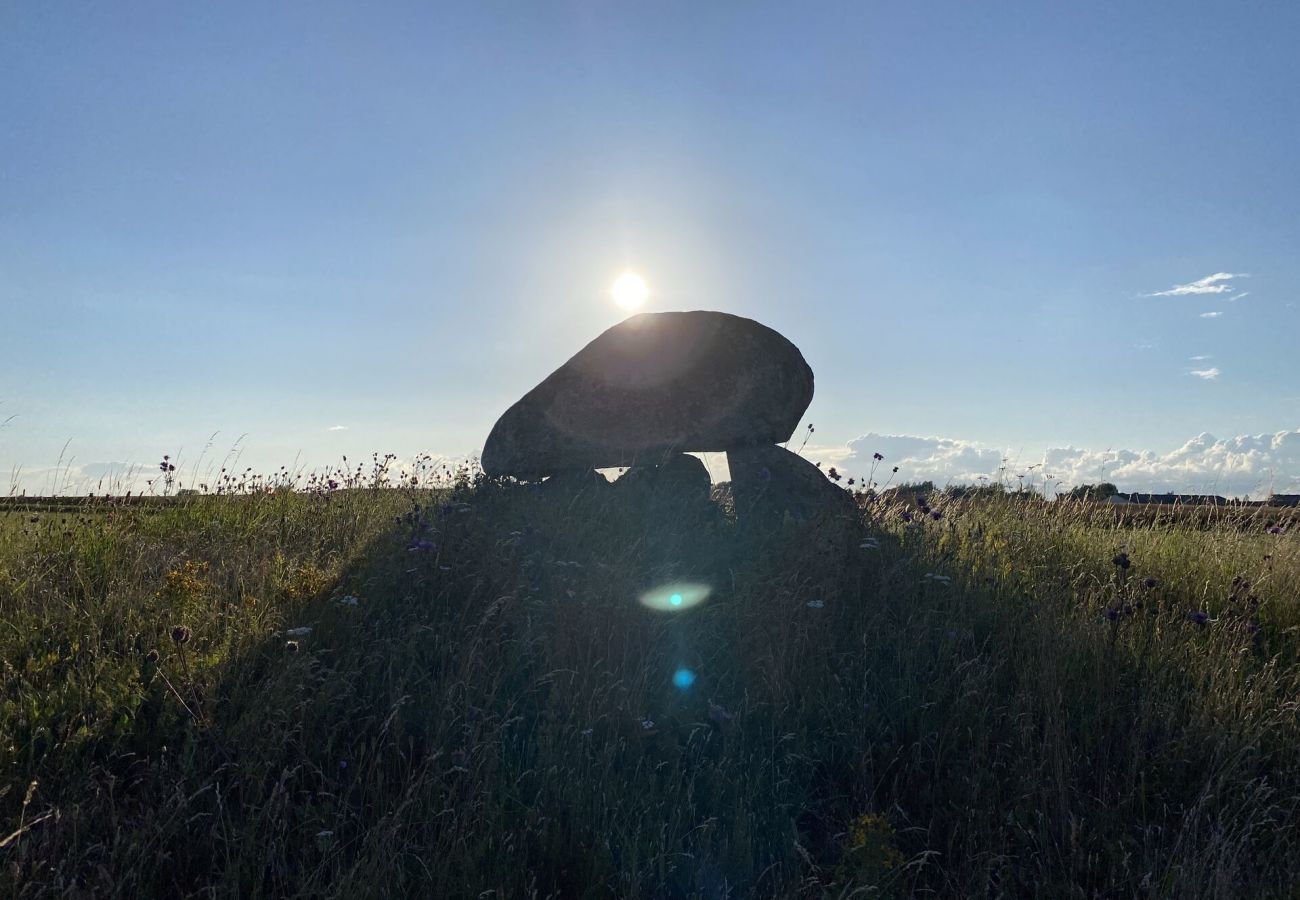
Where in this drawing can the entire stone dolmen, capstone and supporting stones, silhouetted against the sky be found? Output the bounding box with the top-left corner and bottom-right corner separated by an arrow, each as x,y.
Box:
481,311 -> 854,522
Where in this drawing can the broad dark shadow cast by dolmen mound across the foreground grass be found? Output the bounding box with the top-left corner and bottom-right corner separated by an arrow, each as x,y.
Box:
10,483 -> 1300,897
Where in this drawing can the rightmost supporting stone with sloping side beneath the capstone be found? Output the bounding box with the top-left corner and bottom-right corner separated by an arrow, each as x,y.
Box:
727,446 -> 857,524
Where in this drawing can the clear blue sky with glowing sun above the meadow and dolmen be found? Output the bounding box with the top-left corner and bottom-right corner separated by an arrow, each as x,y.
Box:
0,3 -> 1300,492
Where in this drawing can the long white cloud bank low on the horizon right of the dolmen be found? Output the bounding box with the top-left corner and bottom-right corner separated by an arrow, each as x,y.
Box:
835,429 -> 1300,498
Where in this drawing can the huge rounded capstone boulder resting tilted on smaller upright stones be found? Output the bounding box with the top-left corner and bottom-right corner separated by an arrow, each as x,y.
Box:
481,311 -> 813,479
